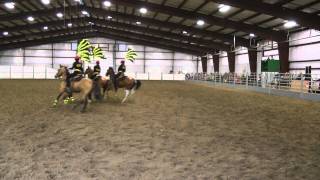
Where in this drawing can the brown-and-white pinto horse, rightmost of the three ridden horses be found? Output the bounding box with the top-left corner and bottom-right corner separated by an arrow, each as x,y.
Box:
106,67 -> 141,103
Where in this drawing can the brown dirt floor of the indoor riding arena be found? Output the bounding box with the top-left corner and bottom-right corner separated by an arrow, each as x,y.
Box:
0,80 -> 320,180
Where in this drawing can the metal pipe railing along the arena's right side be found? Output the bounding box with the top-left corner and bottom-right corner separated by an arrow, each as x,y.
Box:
186,73 -> 320,95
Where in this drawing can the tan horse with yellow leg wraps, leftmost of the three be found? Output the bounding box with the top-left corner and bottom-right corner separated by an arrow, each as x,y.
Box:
55,65 -> 93,112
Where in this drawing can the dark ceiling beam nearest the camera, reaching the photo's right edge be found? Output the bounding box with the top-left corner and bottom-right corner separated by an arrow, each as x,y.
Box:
211,0 -> 320,30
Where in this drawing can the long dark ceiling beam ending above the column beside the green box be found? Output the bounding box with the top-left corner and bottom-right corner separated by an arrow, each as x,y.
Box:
107,0 -> 286,41
